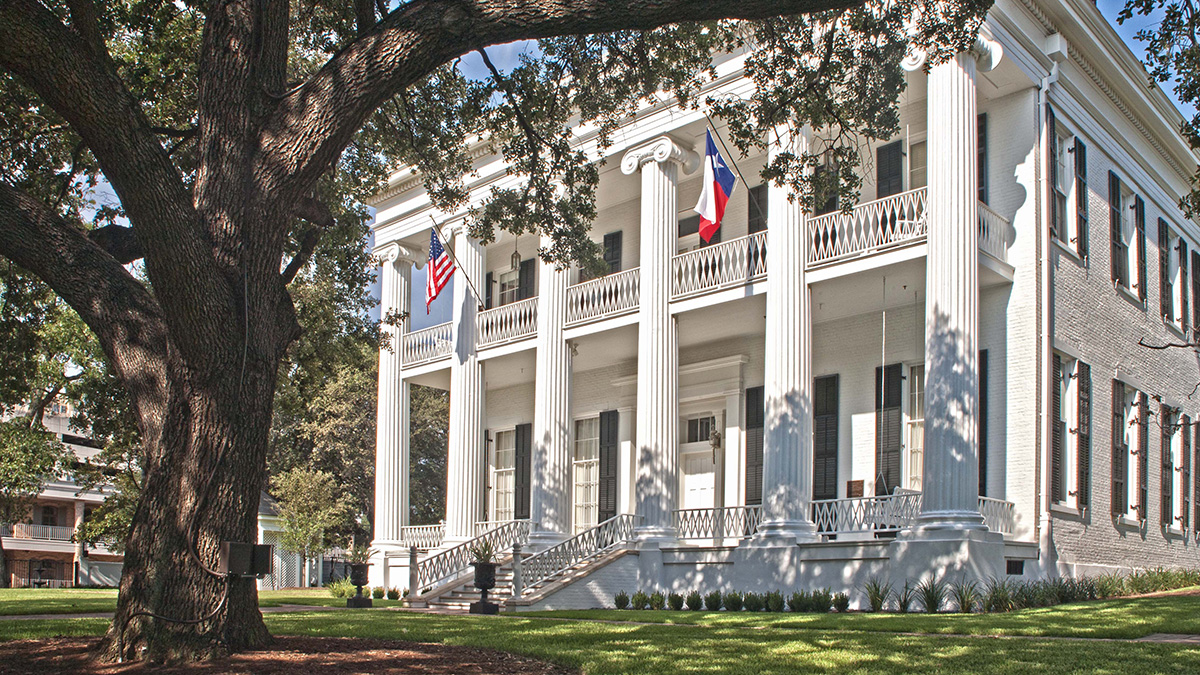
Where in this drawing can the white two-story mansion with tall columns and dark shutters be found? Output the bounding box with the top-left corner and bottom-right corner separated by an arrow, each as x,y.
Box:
362,0 -> 1200,608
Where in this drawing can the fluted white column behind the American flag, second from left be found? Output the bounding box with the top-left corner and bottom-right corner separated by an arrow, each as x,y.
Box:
445,223 -> 486,544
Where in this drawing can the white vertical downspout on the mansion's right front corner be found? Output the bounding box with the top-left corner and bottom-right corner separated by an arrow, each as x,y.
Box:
1033,52 -> 1067,577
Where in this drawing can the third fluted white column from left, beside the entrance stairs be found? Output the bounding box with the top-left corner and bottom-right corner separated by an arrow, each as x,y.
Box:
529,237 -> 571,548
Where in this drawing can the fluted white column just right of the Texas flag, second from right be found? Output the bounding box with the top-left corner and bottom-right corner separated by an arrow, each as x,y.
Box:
756,127 -> 816,544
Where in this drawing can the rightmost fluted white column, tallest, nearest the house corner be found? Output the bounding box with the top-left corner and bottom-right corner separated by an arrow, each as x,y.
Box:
916,38 -> 1000,531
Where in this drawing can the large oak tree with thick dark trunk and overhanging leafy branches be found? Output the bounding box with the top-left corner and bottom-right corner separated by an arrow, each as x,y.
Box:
0,0 -> 990,658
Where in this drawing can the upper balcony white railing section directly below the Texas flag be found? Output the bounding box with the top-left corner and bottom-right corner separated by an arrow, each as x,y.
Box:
671,232 -> 767,299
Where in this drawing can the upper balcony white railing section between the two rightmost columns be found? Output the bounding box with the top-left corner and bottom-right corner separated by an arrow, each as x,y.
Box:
808,187 -> 928,265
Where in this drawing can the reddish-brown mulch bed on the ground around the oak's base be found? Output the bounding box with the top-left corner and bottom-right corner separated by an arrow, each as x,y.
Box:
0,637 -> 574,675
